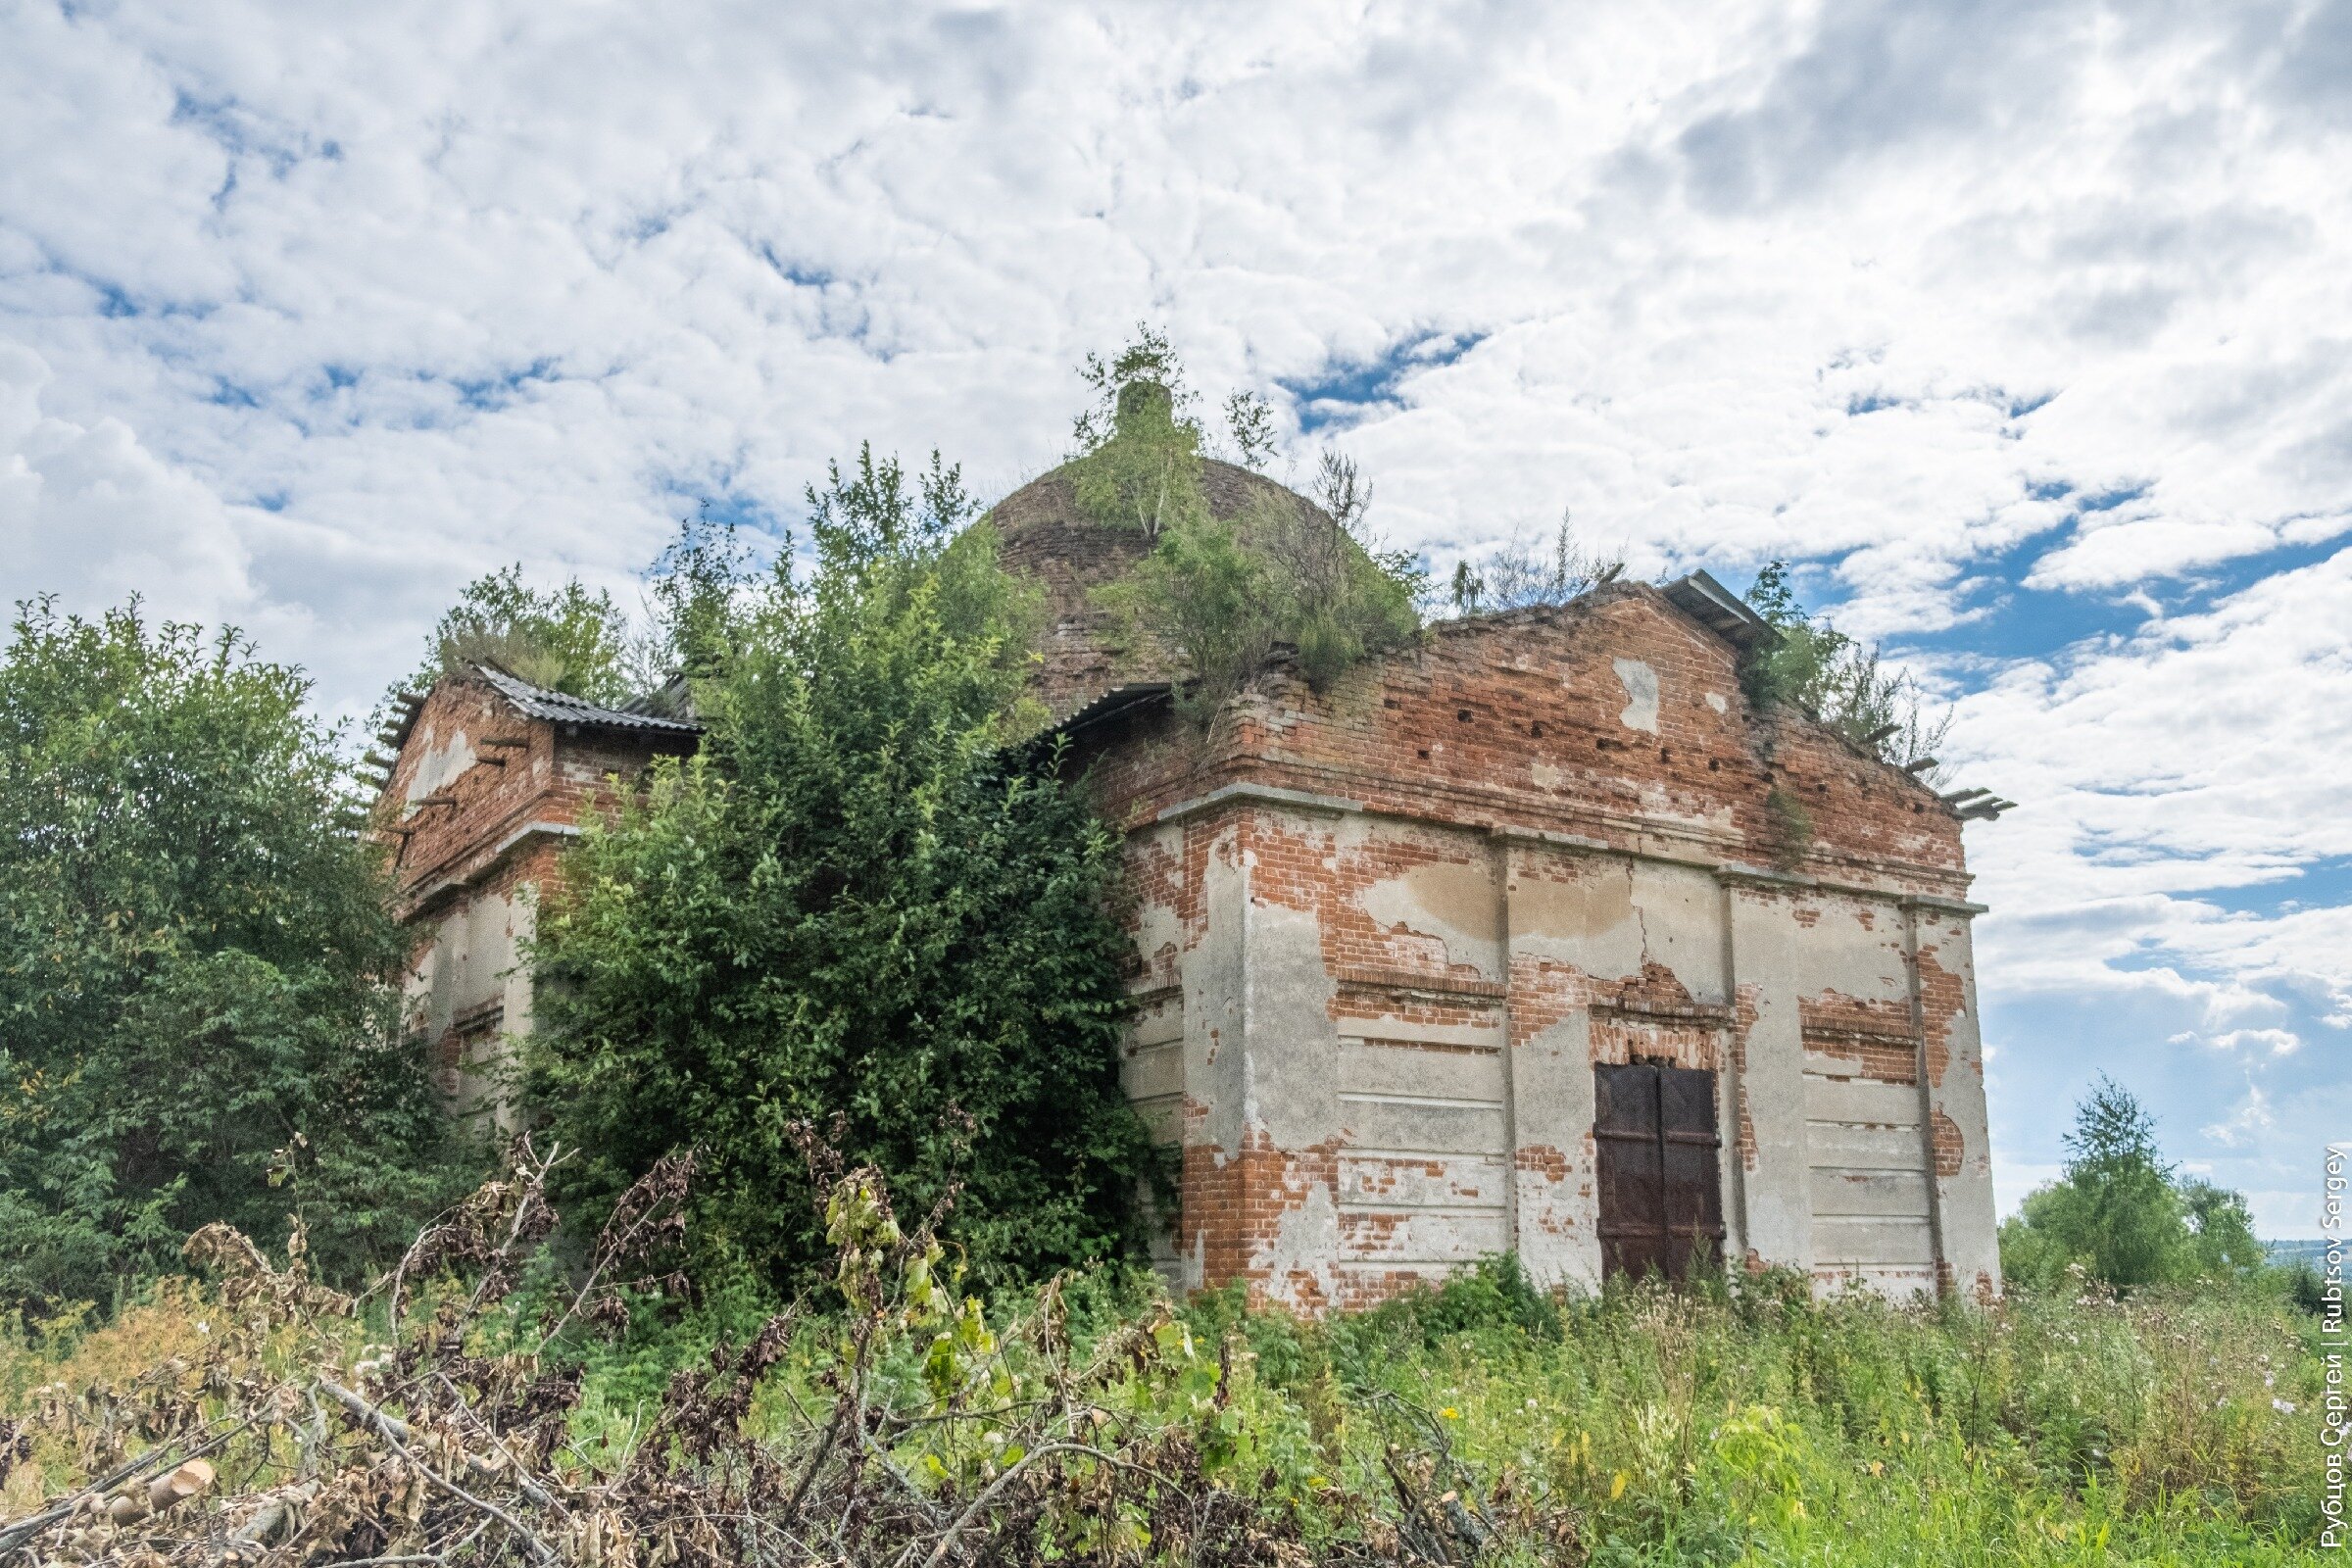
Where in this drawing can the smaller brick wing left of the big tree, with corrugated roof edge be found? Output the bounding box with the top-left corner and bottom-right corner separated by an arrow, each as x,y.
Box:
378,670 -> 699,1119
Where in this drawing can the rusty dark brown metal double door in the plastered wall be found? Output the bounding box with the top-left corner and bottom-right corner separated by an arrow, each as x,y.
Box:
1592,1062 -> 1724,1279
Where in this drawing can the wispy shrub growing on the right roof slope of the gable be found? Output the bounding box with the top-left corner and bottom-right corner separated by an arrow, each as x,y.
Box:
1740,562 -> 1952,766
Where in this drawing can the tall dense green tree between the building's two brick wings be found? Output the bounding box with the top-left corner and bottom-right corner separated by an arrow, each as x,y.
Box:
527,449 -> 1151,1277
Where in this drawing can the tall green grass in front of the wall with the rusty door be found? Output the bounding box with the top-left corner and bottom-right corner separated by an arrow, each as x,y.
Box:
1166,1260 -> 2322,1566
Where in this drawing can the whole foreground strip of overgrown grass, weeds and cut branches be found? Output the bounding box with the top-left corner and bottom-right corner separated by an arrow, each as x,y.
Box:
0,1140 -> 2324,1568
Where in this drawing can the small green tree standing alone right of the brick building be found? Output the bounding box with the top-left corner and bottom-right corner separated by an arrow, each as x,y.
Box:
2001,1077 -> 2263,1291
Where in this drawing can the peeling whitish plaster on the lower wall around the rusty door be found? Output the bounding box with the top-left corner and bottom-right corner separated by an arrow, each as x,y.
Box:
1134,802 -> 1999,1304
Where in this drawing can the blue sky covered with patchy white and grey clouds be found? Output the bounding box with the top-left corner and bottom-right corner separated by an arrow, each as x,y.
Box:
0,0 -> 2352,1237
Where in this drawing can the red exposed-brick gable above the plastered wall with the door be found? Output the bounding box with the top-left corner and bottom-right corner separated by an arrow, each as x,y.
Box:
1082,585 -> 1966,896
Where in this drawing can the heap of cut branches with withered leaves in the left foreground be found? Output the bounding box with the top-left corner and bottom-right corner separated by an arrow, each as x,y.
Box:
0,1128 -> 1492,1568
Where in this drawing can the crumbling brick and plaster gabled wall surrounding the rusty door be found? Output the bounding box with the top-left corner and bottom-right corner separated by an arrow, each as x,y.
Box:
1070,570 -> 1997,1312
